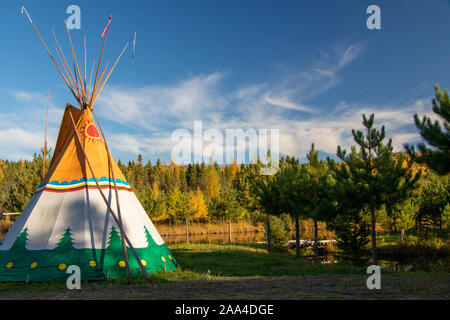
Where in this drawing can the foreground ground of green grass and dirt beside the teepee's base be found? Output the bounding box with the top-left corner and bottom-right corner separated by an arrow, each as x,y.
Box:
0,244 -> 450,299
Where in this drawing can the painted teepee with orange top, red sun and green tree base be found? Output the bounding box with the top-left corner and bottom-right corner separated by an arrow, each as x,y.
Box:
0,8 -> 177,281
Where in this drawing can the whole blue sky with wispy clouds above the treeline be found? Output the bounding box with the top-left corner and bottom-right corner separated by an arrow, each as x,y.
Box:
0,0 -> 450,161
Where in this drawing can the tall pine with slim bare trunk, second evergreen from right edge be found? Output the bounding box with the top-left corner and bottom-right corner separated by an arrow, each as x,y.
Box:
337,114 -> 420,264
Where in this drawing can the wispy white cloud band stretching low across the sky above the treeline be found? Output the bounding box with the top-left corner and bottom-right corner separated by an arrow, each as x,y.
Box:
0,42 -> 430,164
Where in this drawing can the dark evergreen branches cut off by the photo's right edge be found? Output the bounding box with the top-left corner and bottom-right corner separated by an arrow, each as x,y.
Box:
405,85 -> 450,175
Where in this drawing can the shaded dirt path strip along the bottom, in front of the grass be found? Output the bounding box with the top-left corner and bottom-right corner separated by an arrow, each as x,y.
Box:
0,274 -> 450,300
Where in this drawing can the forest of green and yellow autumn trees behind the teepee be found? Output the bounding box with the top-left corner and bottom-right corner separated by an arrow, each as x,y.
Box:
0,87 -> 450,263
